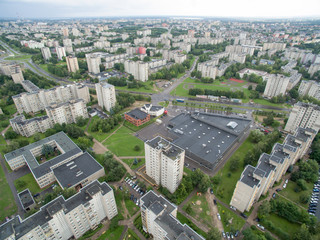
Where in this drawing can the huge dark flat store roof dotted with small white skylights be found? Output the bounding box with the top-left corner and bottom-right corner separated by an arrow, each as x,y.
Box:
169,113 -> 251,164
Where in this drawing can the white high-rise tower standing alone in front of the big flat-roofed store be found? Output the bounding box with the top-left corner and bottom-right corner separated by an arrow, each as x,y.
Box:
144,136 -> 185,193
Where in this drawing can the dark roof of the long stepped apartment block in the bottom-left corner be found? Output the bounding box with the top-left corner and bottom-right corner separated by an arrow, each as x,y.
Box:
0,181 -> 112,240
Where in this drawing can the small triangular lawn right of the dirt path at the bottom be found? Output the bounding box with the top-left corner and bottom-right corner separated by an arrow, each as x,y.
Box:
218,203 -> 246,232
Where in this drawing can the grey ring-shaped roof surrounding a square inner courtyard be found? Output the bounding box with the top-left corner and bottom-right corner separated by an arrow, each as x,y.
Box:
4,132 -> 82,177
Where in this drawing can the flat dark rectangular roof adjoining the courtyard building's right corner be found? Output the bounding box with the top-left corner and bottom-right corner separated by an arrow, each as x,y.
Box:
53,152 -> 103,188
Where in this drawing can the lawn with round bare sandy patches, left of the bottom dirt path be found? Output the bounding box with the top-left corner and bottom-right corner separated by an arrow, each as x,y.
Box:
183,194 -> 213,227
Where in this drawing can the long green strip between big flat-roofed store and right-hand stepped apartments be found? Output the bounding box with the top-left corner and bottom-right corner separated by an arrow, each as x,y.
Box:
213,138 -> 254,204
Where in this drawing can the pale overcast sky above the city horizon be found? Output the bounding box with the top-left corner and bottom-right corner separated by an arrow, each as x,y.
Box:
0,0 -> 320,18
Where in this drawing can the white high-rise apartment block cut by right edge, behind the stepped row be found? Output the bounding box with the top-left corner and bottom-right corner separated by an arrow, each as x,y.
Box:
284,102 -> 320,133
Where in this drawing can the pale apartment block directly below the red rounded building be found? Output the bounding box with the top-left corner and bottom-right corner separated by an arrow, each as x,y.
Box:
124,60 -> 149,82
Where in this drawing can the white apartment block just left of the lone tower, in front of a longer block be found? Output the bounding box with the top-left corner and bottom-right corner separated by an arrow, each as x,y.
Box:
46,99 -> 89,125
